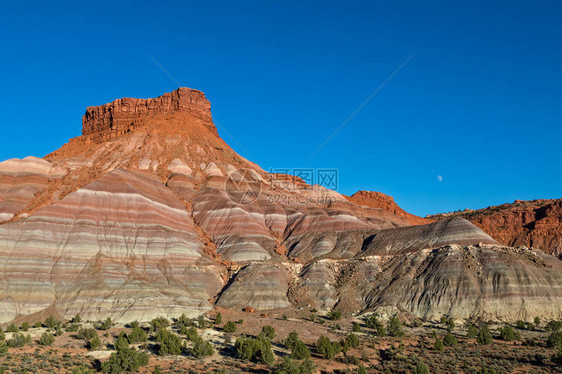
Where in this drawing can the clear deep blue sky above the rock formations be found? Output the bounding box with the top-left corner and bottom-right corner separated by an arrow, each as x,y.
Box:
0,0 -> 562,215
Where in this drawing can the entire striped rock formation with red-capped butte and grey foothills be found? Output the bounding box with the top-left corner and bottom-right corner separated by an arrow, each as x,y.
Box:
0,88 -> 562,323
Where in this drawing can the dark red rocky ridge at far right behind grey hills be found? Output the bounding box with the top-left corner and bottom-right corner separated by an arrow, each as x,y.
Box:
430,199 -> 562,256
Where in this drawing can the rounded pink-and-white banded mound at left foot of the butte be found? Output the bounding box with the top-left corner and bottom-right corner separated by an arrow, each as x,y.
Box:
0,170 -> 223,322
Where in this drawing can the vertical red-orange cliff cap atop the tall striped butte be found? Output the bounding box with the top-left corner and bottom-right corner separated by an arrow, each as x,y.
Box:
82,87 -> 216,141
